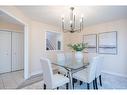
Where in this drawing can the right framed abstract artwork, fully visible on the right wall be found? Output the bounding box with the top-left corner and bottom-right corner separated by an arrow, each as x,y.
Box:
98,31 -> 117,54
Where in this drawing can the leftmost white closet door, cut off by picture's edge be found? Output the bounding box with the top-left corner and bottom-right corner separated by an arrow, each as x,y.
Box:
0,31 -> 11,73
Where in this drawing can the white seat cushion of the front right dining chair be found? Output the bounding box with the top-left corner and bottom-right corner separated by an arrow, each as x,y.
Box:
73,69 -> 92,83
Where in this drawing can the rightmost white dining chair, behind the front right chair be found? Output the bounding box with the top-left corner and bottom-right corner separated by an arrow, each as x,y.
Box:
95,55 -> 104,89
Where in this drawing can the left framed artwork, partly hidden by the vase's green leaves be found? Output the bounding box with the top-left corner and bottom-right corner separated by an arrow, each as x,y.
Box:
83,34 -> 97,53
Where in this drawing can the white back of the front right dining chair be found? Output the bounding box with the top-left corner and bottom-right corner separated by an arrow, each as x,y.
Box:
87,56 -> 99,82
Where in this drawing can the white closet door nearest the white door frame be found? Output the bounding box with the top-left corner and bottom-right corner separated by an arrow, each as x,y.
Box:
12,32 -> 24,71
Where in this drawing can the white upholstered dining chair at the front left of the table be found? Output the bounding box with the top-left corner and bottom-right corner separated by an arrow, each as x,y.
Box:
40,57 -> 69,89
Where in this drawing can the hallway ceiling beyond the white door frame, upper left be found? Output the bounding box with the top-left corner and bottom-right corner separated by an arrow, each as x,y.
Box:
0,11 -> 24,26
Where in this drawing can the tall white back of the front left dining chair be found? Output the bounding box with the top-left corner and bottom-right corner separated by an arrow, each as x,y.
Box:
40,58 -> 53,89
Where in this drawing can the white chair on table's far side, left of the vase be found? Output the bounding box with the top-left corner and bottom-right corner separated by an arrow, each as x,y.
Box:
57,53 -> 67,76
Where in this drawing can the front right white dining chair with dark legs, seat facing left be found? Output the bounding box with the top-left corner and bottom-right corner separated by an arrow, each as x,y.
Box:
73,56 -> 99,89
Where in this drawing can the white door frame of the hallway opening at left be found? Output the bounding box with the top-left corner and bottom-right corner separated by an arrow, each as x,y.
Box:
0,9 -> 30,80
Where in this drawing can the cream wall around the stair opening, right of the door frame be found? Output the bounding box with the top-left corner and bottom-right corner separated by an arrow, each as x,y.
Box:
30,21 -> 64,75
